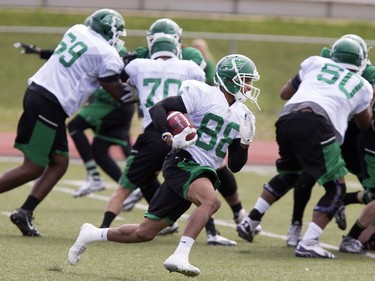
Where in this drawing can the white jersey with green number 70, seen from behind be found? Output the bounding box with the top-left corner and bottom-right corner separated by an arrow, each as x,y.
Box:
125,58 -> 206,130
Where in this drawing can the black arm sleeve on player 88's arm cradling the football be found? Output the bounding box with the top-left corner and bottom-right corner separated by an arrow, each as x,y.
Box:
149,96 -> 186,134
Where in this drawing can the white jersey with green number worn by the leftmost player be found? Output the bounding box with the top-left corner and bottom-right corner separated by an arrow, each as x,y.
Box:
28,24 -> 124,116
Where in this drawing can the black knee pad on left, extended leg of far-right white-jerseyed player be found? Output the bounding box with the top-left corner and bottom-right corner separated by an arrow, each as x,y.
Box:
263,174 -> 298,200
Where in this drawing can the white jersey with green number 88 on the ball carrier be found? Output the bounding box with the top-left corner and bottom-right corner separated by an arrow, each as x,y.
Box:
180,80 -> 255,169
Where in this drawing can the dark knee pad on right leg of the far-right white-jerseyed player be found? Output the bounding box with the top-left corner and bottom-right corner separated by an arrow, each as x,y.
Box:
314,180 -> 342,219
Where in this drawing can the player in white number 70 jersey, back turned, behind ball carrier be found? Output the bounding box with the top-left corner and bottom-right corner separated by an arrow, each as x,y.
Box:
100,33 -> 212,237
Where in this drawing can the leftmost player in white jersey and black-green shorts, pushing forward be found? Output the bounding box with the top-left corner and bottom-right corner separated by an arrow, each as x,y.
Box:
0,9 -> 128,236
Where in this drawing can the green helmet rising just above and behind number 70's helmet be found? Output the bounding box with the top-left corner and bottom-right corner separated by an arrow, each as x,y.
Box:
147,18 -> 182,49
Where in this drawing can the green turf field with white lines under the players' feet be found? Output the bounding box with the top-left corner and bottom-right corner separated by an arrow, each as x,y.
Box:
0,159 -> 375,281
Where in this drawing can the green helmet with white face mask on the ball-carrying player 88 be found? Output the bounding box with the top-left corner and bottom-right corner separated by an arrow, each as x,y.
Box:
215,54 -> 260,108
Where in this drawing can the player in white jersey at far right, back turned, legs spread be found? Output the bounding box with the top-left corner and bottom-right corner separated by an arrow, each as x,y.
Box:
237,38 -> 373,258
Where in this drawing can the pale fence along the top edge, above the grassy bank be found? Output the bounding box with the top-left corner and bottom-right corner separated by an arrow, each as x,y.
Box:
0,0 -> 375,20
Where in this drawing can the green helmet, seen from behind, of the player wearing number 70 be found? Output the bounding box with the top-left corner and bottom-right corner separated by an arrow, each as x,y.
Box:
150,34 -> 181,59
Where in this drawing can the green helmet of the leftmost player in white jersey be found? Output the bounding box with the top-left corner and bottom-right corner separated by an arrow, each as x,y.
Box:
85,9 -> 126,46
